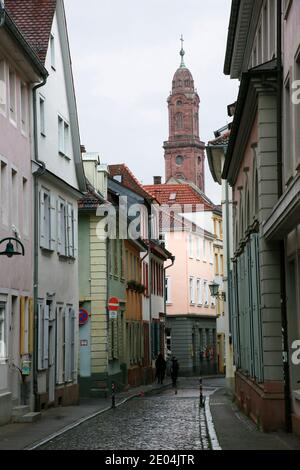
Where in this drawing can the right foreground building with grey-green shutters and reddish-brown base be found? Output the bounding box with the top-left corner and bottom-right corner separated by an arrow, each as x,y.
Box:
223,1 -> 299,430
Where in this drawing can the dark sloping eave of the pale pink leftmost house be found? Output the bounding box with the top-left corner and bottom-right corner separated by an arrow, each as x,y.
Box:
0,4 -> 49,78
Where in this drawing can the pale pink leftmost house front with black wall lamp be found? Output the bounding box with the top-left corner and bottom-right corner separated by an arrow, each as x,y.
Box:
0,6 -> 47,424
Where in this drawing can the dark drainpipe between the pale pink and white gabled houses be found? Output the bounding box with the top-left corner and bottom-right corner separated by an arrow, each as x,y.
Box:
32,76 -> 48,411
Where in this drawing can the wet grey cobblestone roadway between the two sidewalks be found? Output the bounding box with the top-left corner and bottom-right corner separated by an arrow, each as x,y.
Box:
39,383 -> 210,450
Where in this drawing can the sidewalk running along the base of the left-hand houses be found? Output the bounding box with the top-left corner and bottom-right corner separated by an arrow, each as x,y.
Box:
0,380 -> 171,450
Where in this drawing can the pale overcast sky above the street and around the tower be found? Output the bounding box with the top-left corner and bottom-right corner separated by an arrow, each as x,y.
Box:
65,0 -> 238,203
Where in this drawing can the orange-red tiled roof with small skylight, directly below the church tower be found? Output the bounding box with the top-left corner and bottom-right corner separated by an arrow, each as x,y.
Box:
144,184 -> 214,211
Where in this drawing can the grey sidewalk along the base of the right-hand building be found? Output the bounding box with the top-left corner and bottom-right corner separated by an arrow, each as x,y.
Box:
210,389 -> 300,450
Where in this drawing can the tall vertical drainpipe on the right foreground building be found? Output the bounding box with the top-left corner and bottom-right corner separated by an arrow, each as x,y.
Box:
277,0 -> 292,433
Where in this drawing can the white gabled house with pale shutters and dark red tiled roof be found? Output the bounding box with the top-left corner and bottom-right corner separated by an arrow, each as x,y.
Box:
5,0 -> 85,410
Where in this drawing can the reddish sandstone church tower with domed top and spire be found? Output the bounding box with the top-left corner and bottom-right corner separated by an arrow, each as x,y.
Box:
164,39 -> 205,192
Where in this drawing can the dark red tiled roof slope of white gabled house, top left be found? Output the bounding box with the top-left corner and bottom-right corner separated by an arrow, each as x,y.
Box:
5,0 -> 56,64
